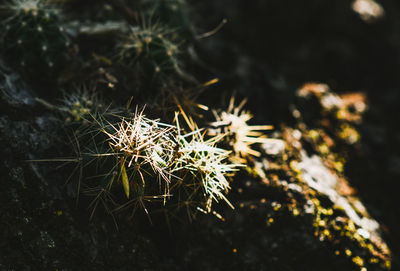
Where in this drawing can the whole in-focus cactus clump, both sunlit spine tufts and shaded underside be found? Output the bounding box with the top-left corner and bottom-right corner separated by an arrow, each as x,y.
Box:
75,107 -> 240,220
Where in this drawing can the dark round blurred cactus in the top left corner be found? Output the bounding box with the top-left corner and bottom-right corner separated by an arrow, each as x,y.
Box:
3,0 -> 69,79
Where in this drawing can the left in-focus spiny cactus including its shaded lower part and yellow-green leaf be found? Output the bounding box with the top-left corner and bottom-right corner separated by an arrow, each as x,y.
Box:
87,109 -> 174,220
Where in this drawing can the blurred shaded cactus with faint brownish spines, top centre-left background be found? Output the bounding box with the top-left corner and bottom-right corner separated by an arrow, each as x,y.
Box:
119,24 -> 181,83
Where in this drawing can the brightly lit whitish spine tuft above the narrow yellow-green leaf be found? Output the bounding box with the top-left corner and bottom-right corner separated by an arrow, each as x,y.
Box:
103,108 -> 175,198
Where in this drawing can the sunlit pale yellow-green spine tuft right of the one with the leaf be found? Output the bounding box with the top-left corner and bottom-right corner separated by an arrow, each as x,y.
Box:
172,111 -> 242,213
